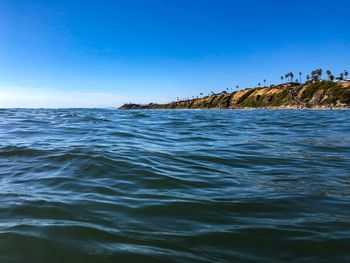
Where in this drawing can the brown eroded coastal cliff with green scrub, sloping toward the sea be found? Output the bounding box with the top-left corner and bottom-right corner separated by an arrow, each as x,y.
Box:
120,81 -> 350,109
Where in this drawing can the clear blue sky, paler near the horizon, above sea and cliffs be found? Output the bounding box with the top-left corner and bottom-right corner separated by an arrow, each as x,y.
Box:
0,0 -> 350,107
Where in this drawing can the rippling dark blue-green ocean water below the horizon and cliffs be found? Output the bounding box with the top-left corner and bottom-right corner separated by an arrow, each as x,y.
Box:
0,109 -> 350,262
